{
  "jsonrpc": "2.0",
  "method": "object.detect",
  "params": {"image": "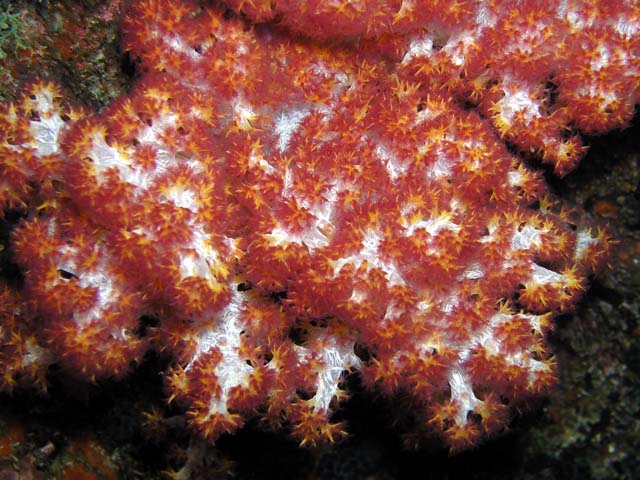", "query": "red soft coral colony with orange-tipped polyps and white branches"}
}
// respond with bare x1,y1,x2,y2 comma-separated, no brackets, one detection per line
0,0,640,450
